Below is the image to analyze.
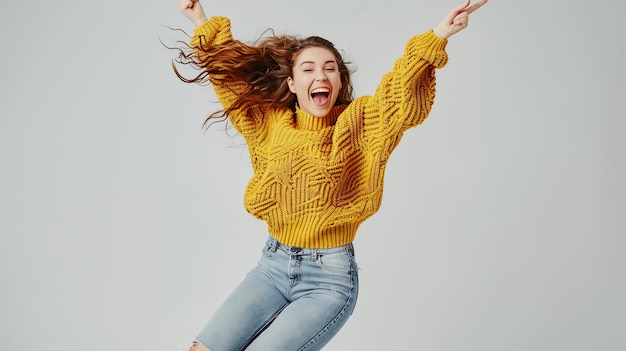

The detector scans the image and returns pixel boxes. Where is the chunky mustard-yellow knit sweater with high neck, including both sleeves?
[191,17,448,248]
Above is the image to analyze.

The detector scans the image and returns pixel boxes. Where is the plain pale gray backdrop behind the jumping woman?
[0,0,626,351]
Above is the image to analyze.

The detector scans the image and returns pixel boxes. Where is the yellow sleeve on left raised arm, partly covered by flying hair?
[191,16,256,139]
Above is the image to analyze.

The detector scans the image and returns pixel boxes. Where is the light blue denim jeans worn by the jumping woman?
[196,237,359,351]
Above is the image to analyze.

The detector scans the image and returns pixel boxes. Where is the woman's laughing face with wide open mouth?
[287,47,342,117]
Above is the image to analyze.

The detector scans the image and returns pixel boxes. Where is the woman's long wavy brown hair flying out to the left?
[172,30,353,126]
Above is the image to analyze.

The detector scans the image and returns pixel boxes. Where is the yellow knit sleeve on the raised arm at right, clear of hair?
[359,30,448,159]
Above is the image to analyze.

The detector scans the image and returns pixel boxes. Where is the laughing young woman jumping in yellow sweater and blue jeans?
[176,0,487,351]
